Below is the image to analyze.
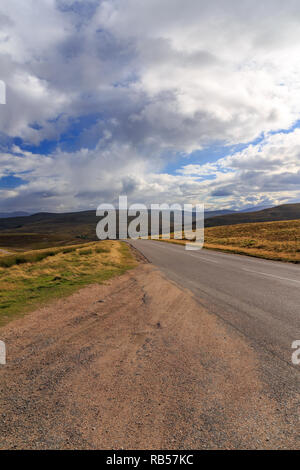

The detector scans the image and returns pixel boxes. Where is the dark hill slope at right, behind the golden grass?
[205,203,300,227]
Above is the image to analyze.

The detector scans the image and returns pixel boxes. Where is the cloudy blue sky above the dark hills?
[0,0,300,212]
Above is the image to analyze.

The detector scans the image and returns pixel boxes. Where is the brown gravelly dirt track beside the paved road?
[0,264,299,449]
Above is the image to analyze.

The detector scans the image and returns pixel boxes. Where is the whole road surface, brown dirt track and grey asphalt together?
[0,241,300,450]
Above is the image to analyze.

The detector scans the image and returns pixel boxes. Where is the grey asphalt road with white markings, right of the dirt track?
[130,240,300,392]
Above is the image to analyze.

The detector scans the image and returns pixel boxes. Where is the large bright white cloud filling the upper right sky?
[96,0,300,146]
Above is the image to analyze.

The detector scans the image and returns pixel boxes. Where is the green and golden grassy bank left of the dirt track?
[0,241,136,326]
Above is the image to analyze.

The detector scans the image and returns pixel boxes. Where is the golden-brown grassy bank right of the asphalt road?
[157,220,300,263]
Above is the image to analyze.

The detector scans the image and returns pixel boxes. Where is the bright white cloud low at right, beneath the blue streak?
[178,129,300,207]
